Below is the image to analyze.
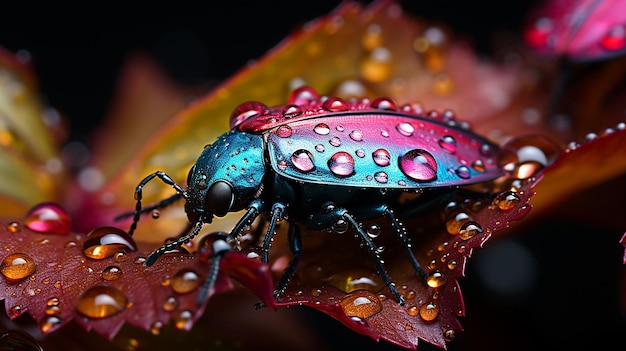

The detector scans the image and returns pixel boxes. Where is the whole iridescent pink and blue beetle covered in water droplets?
[123,87,503,304]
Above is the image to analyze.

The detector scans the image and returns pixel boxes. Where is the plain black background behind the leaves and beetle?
[0,0,626,350]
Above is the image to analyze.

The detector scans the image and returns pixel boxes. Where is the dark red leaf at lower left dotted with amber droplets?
[0,208,273,339]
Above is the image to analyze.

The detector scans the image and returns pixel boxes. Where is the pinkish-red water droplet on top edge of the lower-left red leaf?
[24,202,71,234]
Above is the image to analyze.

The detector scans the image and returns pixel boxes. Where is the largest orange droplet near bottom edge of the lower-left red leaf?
[76,285,128,318]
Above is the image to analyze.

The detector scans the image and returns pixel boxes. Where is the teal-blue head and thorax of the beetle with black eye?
[185,131,265,223]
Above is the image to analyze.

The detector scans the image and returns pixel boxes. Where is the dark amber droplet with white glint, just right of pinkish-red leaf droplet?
[83,227,137,260]
